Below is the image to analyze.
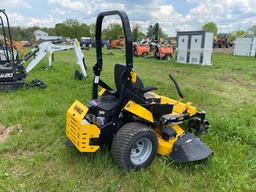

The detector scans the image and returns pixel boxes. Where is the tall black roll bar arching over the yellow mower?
[92,10,133,99]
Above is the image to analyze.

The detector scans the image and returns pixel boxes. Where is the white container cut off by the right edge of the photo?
[233,37,256,57]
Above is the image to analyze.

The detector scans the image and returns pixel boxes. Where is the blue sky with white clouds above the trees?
[0,0,256,36]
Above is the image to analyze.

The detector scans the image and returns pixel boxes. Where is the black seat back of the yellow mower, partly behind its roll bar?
[114,64,144,95]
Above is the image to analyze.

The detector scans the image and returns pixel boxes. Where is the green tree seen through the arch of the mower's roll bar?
[102,23,124,39]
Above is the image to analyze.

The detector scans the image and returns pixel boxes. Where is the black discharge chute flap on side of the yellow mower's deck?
[169,133,213,163]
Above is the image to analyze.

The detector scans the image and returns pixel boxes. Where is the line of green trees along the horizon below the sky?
[0,19,256,41]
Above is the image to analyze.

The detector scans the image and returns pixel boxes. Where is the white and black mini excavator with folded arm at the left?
[0,10,87,91]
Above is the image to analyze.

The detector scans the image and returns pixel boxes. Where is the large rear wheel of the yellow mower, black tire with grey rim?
[111,122,158,170]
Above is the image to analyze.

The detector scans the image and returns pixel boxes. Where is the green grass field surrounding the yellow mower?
[0,49,256,192]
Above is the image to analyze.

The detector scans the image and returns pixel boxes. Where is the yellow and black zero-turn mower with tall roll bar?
[66,11,212,170]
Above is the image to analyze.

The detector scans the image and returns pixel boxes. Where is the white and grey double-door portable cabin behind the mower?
[176,31,213,65]
